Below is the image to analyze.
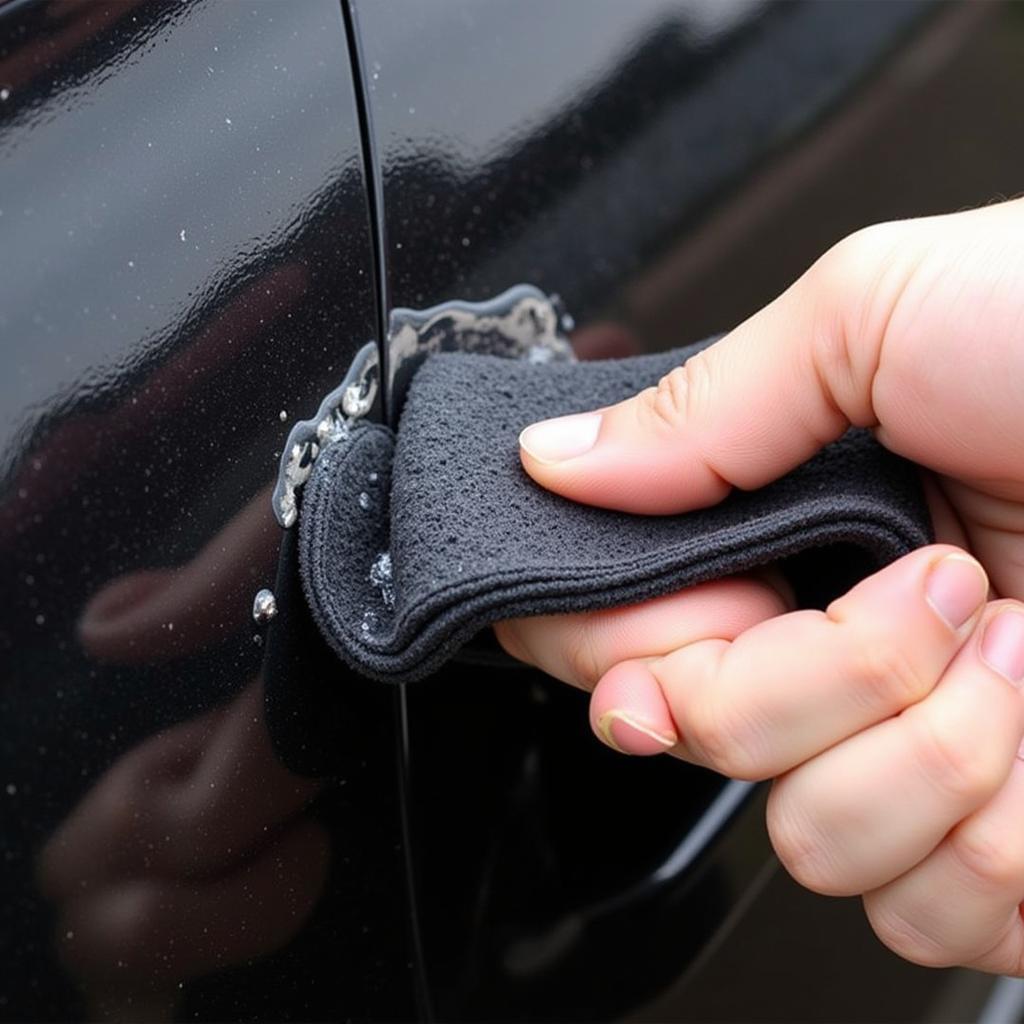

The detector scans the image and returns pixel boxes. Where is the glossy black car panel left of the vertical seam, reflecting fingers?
[0,0,415,1020]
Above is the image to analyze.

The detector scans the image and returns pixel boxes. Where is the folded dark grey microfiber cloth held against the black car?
[299,345,930,683]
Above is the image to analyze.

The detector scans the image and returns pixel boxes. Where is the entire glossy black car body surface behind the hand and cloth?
[0,0,1024,1021]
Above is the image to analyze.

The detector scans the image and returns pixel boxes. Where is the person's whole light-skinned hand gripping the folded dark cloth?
[496,201,1024,976]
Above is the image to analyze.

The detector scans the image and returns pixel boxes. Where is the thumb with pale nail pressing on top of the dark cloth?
[519,222,919,514]
